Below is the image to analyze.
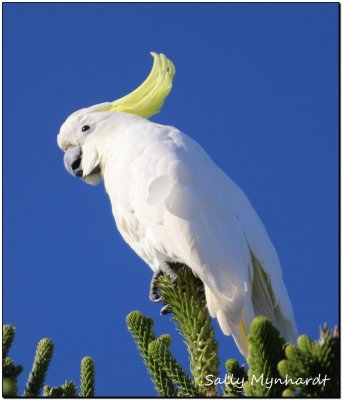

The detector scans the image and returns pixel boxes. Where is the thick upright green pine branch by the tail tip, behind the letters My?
[244,317,285,397]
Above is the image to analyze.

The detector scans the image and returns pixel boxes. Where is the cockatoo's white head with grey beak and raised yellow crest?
[57,53,175,184]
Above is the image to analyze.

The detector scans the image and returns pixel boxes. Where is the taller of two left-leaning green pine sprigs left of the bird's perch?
[126,311,177,397]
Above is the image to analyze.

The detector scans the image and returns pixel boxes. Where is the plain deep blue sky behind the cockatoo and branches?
[3,3,338,396]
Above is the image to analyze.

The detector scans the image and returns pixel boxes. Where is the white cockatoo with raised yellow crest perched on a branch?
[57,53,297,357]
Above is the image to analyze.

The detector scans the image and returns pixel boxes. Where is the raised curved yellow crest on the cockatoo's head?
[97,52,175,118]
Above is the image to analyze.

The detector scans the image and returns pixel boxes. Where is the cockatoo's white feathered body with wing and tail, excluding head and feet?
[99,116,297,356]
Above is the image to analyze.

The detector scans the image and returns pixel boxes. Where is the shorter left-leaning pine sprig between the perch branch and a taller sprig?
[148,335,203,397]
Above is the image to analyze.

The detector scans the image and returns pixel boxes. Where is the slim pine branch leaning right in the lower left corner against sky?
[23,339,53,397]
